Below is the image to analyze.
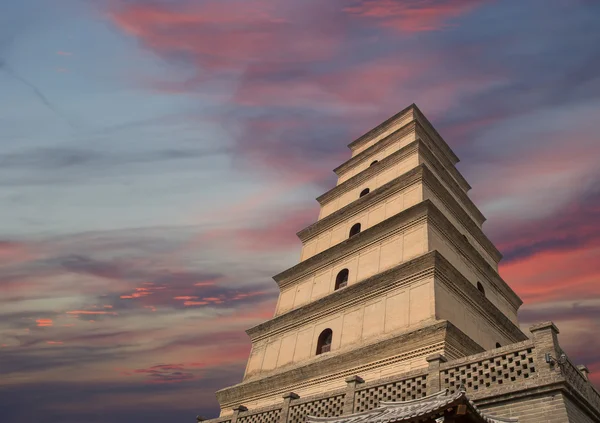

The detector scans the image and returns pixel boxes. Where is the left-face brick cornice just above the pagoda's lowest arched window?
[246,251,439,342]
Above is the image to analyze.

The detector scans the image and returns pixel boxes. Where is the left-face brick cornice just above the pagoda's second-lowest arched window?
[273,200,435,288]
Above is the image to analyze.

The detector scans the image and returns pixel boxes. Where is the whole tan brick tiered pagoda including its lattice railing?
[198,104,600,423]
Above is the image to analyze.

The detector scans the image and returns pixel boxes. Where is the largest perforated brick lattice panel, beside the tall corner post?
[440,347,536,391]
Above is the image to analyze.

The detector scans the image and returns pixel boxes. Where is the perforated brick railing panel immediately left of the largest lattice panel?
[354,375,427,413]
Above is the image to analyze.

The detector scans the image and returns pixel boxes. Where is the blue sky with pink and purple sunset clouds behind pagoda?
[0,0,600,423]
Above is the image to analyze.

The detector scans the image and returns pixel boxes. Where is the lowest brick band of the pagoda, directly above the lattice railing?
[216,320,484,416]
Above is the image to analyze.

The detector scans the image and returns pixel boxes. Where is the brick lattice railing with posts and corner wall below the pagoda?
[197,322,600,423]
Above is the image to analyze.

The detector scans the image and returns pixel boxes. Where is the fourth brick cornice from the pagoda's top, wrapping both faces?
[297,161,502,262]
